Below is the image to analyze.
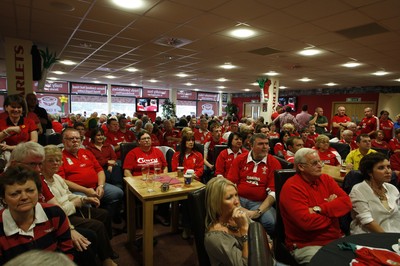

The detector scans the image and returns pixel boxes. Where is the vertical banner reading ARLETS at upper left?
[5,37,33,95]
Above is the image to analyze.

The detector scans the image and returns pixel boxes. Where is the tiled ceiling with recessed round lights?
[0,0,400,92]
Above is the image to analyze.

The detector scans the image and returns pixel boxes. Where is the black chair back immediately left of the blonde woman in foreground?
[188,187,211,266]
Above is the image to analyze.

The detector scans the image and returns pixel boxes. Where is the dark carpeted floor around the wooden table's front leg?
[111,221,199,266]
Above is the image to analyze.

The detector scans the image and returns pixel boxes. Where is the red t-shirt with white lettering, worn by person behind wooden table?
[123,147,168,176]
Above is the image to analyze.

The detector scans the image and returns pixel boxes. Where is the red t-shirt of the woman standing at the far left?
[0,117,38,146]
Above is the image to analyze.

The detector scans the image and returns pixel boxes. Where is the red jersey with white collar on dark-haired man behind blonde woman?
[227,152,282,201]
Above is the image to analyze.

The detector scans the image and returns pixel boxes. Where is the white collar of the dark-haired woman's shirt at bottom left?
[2,203,49,237]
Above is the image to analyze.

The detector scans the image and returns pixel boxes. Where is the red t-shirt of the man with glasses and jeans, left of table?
[58,149,103,189]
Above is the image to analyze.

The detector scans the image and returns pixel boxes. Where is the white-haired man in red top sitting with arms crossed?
[279,148,351,264]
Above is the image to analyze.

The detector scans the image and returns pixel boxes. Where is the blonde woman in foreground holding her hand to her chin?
[204,177,250,266]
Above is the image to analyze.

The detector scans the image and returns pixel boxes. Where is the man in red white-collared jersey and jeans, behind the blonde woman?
[227,133,282,235]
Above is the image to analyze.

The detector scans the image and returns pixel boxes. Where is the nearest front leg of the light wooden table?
[143,201,154,266]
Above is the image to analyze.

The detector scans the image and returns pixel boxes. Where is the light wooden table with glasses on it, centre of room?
[124,172,204,266]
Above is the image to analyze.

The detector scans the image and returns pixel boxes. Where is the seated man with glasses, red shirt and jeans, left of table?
[58,128,124,220]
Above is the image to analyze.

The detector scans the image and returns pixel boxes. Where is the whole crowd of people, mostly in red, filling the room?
[0,94,400,265]
